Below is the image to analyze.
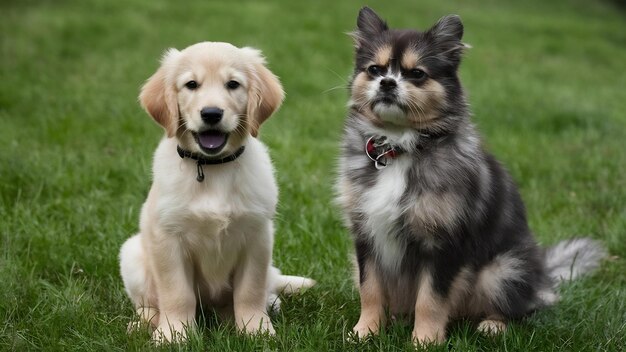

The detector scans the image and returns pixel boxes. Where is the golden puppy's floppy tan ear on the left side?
[139,49,180,137]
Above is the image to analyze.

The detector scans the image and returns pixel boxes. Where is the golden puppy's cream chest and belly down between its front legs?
[144,141,278,287]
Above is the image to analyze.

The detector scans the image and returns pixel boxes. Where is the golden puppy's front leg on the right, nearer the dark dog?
[233,223,274,335]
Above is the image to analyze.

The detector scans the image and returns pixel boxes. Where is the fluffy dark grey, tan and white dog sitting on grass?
[337,8,605,343]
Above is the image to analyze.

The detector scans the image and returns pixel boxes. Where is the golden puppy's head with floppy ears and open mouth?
[139,42,284,156]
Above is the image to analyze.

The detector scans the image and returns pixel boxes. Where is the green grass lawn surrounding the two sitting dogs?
[0,0,626,351]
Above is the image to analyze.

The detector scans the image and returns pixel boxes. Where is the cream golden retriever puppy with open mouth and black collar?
[120,42,314,341]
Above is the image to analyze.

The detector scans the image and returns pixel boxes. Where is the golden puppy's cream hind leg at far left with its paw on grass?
[120,235,159,331]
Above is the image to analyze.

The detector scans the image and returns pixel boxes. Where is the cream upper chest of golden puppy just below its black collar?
[154,139,278,228]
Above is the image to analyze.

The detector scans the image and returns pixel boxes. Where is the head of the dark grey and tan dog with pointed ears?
[350,7,466,129]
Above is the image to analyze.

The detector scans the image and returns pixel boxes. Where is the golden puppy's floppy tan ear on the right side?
[242,48,285,137]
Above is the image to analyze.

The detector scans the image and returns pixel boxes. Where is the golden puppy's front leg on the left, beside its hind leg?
[150,237,196,342]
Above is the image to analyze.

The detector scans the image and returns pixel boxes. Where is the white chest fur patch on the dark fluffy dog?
[360,157,411,272]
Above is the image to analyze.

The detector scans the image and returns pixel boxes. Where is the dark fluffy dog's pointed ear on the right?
[427,15,470,63]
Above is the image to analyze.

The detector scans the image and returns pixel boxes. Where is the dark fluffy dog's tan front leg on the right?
[412,272,450,344]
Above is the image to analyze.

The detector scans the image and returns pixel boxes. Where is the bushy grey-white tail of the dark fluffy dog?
[545,238,607,287]
